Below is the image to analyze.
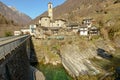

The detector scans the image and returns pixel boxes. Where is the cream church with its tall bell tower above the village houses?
[39,2,66,28]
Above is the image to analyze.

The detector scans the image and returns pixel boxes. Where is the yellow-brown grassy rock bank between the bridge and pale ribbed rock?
[32,38,61,65]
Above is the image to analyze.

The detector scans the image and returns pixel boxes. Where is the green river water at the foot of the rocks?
[36,64,73,80]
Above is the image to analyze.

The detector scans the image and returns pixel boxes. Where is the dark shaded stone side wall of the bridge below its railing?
[0,43,30,80]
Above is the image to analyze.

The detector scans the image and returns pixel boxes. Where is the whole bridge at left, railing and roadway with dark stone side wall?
[0,35,36,80]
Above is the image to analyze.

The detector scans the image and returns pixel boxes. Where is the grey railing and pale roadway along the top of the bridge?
[0,35,30,60]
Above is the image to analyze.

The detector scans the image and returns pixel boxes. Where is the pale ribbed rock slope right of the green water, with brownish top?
[60,39,115,77]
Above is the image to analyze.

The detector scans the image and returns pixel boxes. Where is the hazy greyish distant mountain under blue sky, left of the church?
[0,2,31,25]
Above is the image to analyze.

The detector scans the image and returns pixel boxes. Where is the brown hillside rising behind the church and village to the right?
[32,0,120,39]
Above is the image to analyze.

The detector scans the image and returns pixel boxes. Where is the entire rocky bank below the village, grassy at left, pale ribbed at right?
[33,38,119,78]
